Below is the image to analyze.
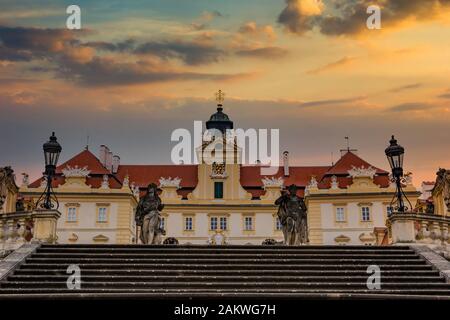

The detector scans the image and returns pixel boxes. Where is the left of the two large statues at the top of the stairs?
[135,183,165,244]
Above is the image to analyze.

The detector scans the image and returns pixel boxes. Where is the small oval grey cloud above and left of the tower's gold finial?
[134,41,225,65]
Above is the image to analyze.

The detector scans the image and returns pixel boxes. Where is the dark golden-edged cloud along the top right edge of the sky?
[278,0,450,36]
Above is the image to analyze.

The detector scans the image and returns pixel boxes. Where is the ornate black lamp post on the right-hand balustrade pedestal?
[385,136,409,212]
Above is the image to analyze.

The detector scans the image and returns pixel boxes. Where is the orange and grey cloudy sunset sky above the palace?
[0,0,450,186]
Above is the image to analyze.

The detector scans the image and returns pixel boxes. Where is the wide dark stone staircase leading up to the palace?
[0,245,450,299]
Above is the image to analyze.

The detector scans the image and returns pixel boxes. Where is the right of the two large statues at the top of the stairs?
[275,185,309,245]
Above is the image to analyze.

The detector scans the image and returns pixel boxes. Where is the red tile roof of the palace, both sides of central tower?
[25,150,389,198]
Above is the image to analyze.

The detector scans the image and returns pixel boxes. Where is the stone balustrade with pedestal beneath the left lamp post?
[0,210,61,253]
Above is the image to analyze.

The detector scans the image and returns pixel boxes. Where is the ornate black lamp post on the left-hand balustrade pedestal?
[36,132,62,210]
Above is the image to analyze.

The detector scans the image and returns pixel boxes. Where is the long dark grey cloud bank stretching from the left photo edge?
[0,24,249,86]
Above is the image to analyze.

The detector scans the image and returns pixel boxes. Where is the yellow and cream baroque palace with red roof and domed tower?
[19,104,419,245]
